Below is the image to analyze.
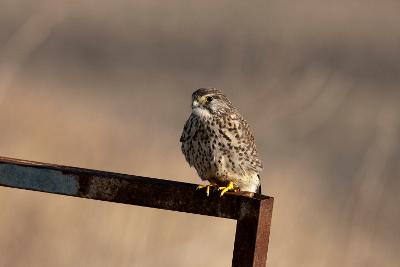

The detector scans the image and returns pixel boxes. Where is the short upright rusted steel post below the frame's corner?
[232,197,274,267]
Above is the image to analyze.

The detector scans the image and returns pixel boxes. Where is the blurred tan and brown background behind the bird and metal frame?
[0,0,400,267]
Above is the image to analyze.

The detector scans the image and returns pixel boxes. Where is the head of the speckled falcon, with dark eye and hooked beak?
[192,88,234,117]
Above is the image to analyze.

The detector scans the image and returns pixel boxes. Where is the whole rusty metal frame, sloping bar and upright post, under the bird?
[0,157,274,267]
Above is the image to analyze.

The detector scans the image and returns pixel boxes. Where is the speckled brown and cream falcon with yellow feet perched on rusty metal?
[180,88,263,196]
